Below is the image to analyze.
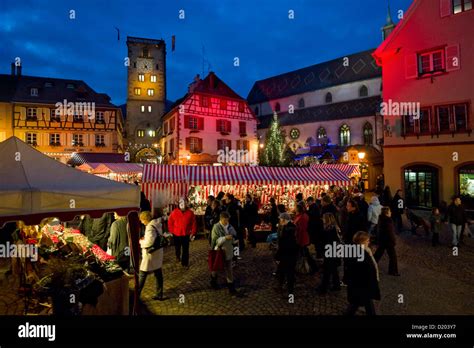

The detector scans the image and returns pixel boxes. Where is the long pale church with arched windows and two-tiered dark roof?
[247,50,383,188]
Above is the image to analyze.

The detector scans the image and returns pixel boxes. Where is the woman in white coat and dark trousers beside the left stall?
[138,211,164,301]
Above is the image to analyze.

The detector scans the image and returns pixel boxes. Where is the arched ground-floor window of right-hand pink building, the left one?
[404,166,439,208]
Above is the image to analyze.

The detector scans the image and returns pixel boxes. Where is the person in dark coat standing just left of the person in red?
[275,213,298,295]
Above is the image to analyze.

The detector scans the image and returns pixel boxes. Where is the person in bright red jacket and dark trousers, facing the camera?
[168,198,196,267]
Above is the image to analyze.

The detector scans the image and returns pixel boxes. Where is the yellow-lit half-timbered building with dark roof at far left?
[0,67,124,163]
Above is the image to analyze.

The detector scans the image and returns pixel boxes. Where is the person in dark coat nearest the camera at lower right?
[344,232,380,316]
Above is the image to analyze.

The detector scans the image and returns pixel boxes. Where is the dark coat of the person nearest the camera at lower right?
[344,251,380,306]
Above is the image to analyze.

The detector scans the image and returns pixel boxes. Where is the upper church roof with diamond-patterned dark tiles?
[247,49,382,104]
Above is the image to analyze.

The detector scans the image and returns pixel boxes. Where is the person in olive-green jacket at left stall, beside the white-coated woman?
[107,213,130,269]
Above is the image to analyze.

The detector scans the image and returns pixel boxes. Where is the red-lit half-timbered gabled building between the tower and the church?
[161,72,258,165]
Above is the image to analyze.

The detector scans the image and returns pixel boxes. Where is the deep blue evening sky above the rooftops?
[0,0,412,104]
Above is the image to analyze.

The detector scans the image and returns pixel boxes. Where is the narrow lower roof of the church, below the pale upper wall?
[258,96,382,129]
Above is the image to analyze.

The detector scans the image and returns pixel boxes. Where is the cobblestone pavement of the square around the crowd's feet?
[136,222,474,315]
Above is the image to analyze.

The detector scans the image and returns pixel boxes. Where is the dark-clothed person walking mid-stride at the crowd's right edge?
[374,207,400,276]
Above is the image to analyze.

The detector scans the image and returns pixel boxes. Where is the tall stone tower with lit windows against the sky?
[125,36,166,162]
